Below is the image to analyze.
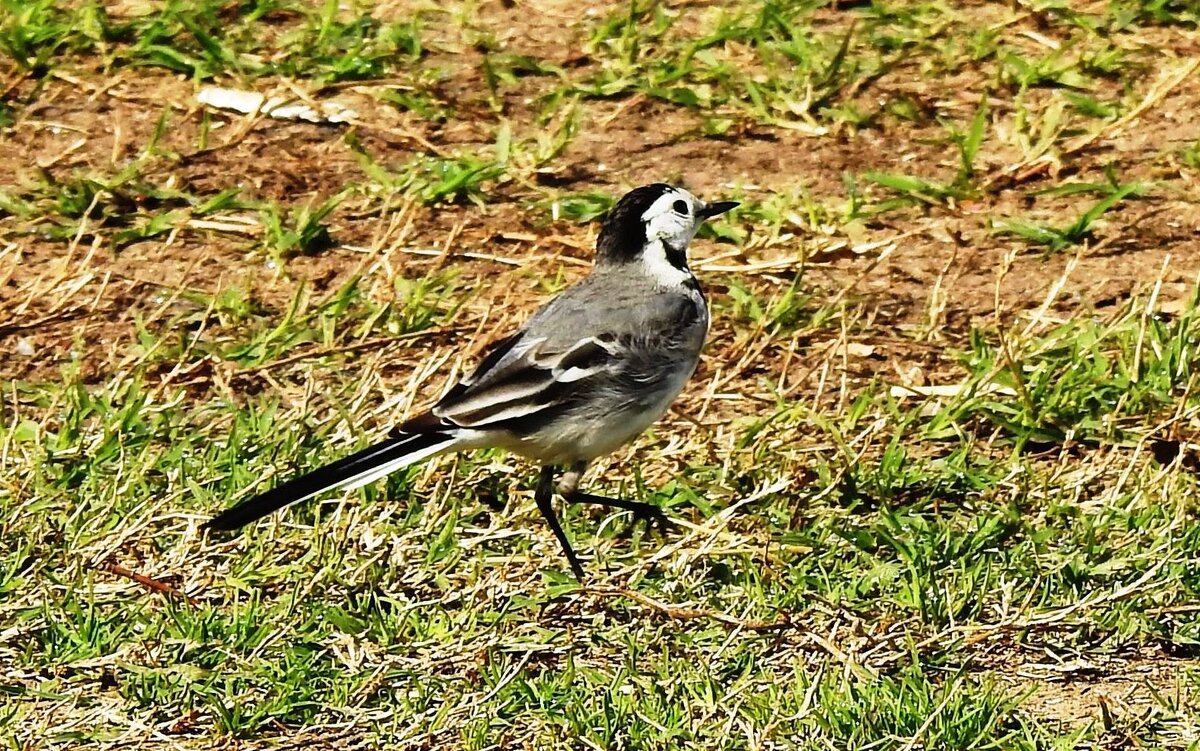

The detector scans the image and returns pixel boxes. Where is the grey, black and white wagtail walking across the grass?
[205,182,737,581]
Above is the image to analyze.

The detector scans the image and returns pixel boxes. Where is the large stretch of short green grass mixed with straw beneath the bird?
[9,279,1200,749]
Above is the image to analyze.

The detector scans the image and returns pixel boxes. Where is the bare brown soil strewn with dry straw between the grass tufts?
[0,2,1200,722]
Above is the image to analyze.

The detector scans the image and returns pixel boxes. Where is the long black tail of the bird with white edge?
[204,433,455,529]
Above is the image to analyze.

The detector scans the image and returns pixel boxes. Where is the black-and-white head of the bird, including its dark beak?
[596,182,738,271]
